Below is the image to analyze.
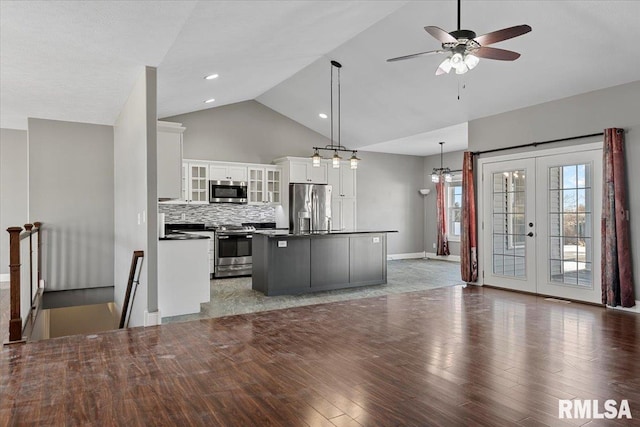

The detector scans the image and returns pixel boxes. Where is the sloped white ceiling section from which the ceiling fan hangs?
[257,0,640,154]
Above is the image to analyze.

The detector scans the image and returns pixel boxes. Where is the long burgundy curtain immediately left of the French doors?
[460,151,478,283]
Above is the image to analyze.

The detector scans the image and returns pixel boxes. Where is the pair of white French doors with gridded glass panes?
[481,144,602,303]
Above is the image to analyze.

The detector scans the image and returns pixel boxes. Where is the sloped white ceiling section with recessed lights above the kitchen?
[158,1,404,117]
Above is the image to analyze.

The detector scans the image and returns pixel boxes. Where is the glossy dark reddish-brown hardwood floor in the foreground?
[0,287,640,427]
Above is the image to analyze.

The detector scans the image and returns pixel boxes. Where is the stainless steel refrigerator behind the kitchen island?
[289,184,332,234]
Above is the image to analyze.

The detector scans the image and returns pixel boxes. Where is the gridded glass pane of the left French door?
[492,170,526,278]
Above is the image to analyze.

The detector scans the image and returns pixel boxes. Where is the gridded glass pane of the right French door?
[548,164,593,287]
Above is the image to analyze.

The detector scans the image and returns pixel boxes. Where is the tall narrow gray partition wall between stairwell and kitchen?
[111,67,158,326]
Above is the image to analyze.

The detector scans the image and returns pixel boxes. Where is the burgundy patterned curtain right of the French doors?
[601,128,635,307]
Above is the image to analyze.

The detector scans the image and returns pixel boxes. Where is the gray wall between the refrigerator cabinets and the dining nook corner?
[357,151,424,255]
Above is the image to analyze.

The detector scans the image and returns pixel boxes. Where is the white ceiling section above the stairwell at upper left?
[0,0,196,129]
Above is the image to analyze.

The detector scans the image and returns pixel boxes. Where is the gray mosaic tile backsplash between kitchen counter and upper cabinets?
[158,203,276,225]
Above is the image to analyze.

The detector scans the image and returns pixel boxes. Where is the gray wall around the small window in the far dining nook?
[422,151,464,256]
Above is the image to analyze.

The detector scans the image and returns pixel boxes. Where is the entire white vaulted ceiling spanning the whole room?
[0,0,640,155]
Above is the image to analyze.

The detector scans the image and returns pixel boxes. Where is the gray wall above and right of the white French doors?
[469,81,640,299]
